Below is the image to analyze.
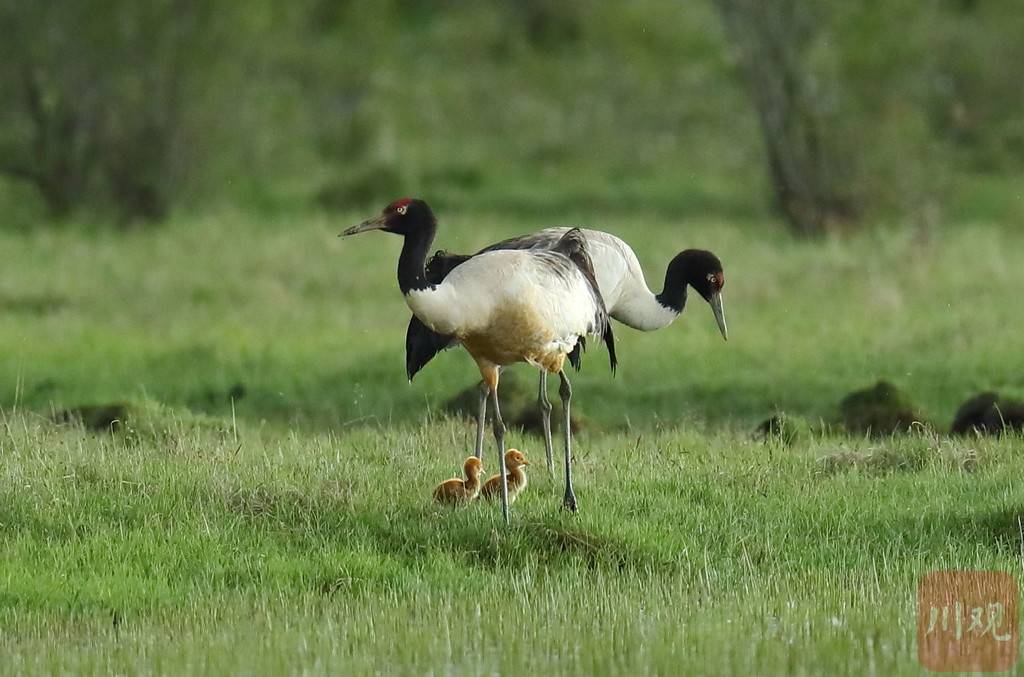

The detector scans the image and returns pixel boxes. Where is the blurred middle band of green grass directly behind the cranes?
[0,212,1024,430]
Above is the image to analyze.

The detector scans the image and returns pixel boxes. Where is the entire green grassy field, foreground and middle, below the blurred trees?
[0,212,1024,675]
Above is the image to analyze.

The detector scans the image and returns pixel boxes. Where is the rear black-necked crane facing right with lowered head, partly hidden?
[406,227,728,472]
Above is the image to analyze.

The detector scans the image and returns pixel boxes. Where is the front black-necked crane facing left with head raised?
[342,198,614,523]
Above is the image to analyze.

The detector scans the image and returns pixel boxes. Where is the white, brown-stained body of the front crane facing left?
[406,250,602,372]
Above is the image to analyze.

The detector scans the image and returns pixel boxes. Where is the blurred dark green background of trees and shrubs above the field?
[0,0,1024,235]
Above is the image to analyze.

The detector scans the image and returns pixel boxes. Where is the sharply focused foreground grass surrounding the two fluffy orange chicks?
[0,416,1024,674]
